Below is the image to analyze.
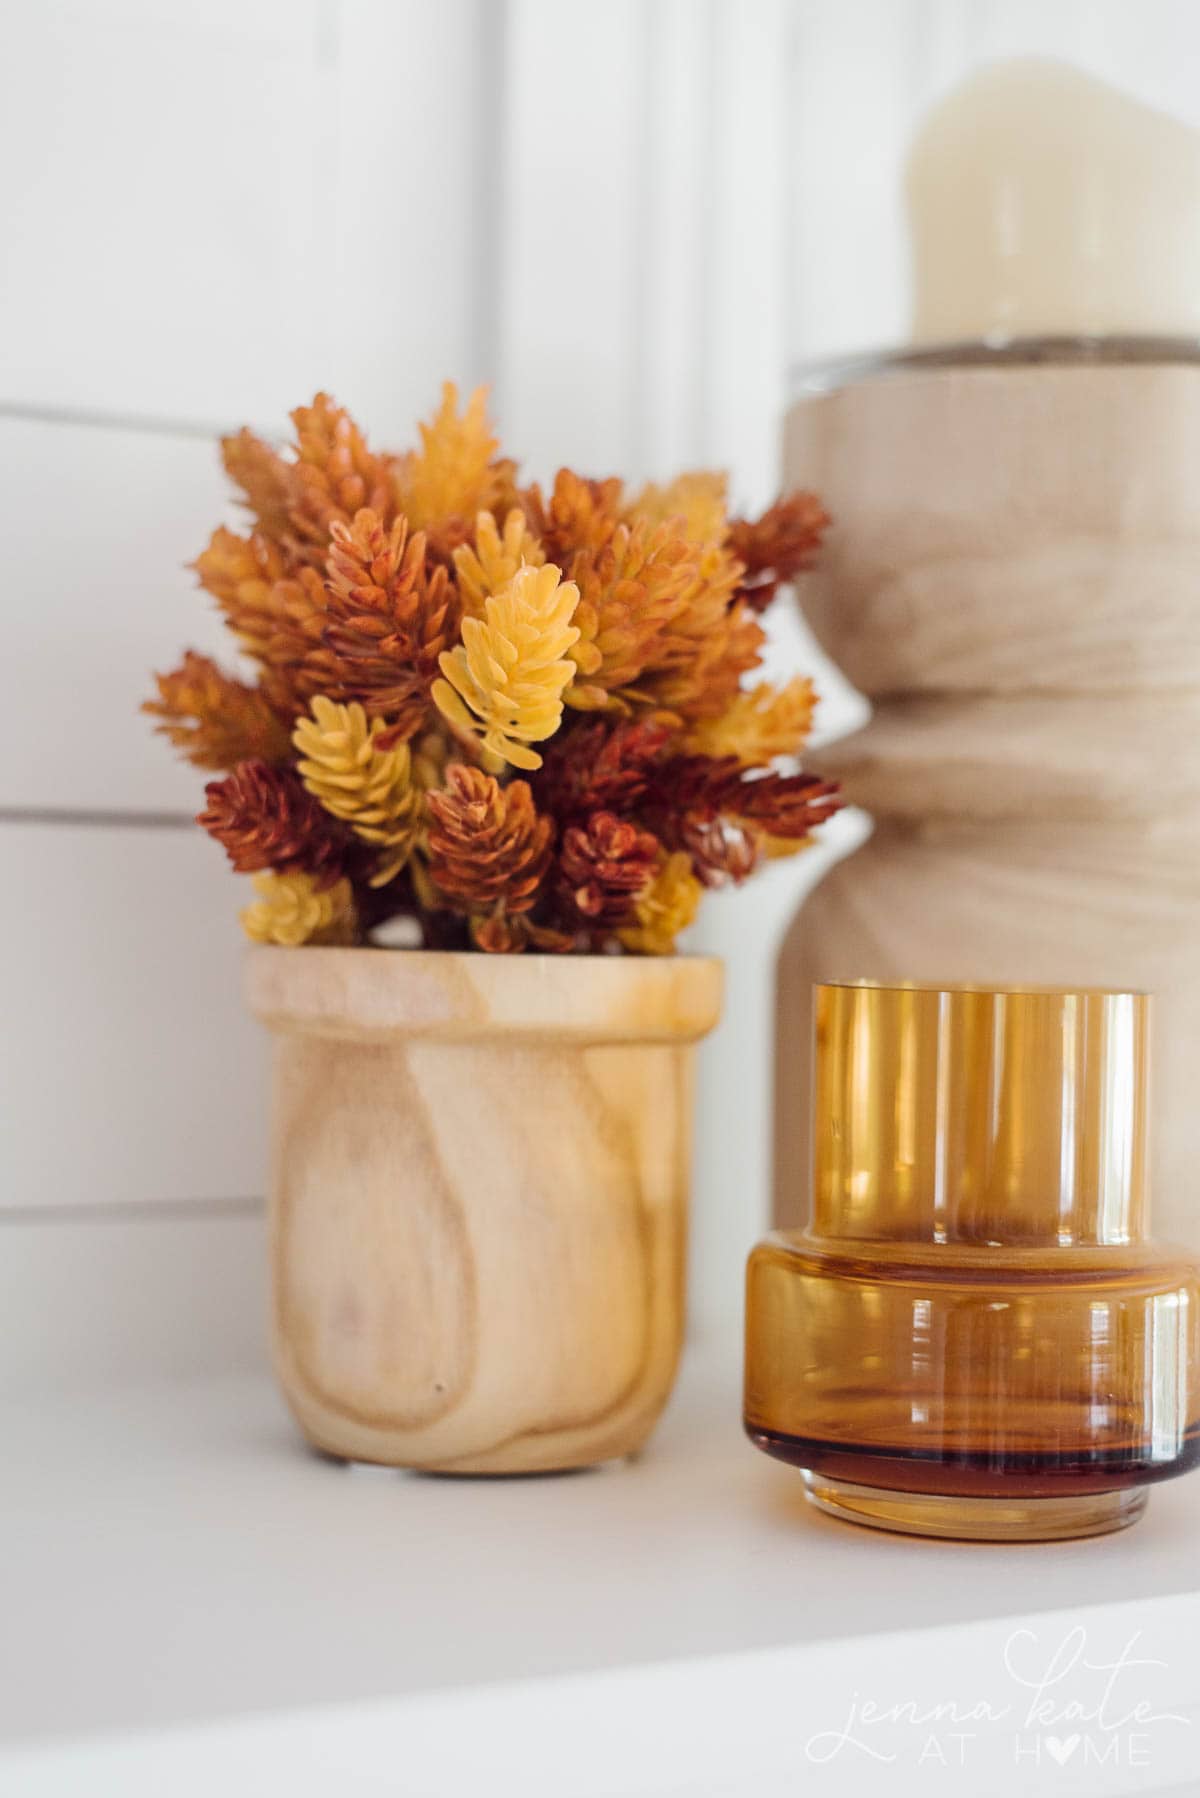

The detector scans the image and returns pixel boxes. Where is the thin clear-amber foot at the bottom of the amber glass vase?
[802,1467,1148,1543]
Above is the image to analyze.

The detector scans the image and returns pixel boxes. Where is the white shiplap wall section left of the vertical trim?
[0,0,502,1375]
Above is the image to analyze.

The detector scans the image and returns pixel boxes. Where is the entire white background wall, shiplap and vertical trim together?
[0,0,1196,1374]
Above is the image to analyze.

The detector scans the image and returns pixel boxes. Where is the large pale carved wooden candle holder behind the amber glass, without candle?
[777,354,1200,1246]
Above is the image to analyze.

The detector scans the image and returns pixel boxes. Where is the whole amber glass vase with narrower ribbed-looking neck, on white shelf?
[745,984,1200,1541]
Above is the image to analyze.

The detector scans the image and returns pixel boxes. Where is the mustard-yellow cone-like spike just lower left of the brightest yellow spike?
[291,694,421,886]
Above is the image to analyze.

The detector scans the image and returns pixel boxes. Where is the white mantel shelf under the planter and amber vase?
[0,1340,1200,1798]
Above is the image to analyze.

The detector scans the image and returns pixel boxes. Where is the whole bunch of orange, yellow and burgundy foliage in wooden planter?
[144,383,838,955]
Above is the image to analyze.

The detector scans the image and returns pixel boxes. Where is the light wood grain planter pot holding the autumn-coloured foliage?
[239,948,721,1473]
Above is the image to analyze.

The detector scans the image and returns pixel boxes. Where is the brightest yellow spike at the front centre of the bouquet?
[432,563,579,768]
